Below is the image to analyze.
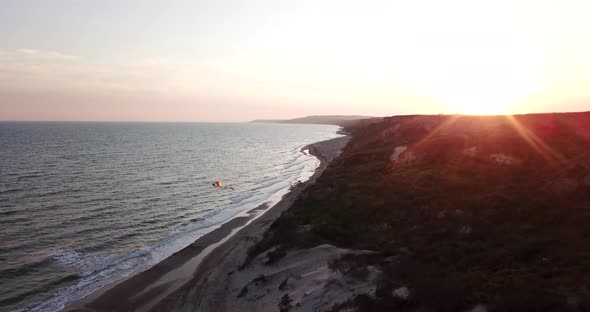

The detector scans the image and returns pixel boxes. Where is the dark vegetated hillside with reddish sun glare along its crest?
[243,113,590,311]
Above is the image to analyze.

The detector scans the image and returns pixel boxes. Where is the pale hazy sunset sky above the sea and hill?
[0,0,590,121]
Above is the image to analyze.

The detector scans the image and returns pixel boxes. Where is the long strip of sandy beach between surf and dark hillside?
[65,136,350,311]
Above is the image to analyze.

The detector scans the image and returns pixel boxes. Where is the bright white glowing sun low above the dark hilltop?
[404,33,539,115]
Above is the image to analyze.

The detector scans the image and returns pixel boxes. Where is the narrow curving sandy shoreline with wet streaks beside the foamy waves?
[64,136,350,311]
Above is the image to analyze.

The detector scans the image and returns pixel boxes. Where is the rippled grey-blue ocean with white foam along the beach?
[0,122,339,311]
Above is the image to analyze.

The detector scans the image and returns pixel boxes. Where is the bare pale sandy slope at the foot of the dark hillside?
[198,245,380,311]
